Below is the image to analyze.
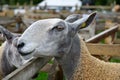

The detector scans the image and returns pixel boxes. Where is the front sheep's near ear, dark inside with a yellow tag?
[73,12,96,31]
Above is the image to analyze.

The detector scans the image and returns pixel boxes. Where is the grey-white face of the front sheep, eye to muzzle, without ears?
[18,19,72,57]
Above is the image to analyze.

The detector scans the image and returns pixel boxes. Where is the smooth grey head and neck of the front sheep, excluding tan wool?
[17,12,96,80]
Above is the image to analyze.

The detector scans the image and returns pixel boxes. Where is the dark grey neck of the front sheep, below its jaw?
[56,35,80,80]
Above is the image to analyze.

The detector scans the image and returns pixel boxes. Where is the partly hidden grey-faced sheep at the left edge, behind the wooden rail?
[0,26,27,80]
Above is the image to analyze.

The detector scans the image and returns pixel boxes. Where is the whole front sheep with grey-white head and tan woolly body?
[17,13,120,80]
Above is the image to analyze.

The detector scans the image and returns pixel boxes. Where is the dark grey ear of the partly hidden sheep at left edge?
[0,26,14,41]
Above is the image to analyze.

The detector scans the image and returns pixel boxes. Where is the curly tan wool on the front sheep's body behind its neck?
[72,40,120,80]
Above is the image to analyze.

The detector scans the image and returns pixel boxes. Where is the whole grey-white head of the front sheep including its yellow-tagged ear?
[18,13,96,58]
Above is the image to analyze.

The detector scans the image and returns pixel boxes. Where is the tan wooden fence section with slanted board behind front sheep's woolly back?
[86,25,120,56]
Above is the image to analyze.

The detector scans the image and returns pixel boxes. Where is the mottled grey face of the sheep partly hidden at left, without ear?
[4,35,26,67]
